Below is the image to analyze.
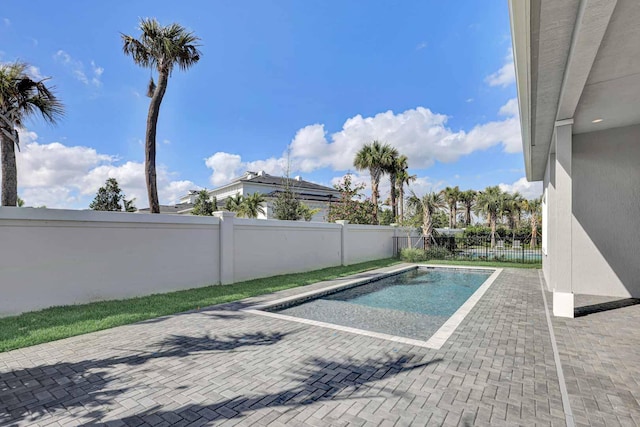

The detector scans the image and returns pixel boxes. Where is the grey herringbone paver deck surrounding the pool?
[0,269,640,426]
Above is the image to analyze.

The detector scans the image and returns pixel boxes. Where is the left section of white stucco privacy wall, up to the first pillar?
[0,207,220,315]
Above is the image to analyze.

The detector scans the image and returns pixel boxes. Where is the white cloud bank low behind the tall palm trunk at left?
[2,130,198,209]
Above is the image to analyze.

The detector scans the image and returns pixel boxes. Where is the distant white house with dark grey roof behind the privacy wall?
[178,171,340,221]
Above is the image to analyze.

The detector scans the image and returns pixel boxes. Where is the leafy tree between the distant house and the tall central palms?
[327,174,378,224]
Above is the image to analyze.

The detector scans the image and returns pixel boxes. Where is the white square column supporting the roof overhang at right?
[550,119,574,317]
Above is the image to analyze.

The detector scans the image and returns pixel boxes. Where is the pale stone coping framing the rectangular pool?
[242,264,503,350]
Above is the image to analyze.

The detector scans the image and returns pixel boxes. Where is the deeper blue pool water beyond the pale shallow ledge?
[323,269,491,316]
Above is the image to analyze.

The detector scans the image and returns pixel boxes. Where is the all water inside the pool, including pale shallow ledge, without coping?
[269,268,493,340]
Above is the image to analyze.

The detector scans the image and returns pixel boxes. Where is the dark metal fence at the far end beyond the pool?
[393,235,542,264]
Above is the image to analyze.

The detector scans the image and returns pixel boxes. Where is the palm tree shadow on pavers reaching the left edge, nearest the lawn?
[0,332,289,425]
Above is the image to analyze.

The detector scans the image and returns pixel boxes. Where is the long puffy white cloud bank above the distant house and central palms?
[205,100,522,185]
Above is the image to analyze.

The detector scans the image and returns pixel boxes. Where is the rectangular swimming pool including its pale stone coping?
[252,266,498,348]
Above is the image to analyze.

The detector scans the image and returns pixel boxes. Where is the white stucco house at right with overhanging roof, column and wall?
[509,0,640,317]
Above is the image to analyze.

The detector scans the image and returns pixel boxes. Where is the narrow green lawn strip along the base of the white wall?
[0,258,400,352]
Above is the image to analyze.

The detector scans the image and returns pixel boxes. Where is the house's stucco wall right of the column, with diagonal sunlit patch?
[572,126,640,297]
